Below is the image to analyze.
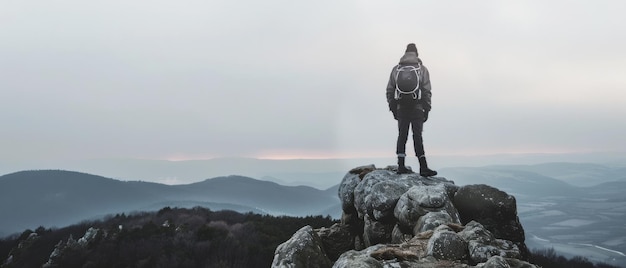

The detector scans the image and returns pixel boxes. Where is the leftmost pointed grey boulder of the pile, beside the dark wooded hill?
[272,225,332,268]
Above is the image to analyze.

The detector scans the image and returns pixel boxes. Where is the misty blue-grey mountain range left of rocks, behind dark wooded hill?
[0,170,340,236]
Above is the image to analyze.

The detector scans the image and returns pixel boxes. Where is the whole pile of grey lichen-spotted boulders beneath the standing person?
[272,165,535,268]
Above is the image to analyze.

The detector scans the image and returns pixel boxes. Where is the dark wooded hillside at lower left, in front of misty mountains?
[0,207,334,268]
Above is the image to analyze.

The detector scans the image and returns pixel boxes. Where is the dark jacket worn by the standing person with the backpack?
[387,52,432,117]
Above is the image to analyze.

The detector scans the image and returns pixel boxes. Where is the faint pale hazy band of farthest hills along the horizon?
[0,152,626,190]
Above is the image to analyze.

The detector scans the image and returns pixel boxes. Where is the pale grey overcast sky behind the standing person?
[0,0,626,161]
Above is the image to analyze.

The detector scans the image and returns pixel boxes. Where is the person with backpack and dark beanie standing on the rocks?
[387,43,437,177]
